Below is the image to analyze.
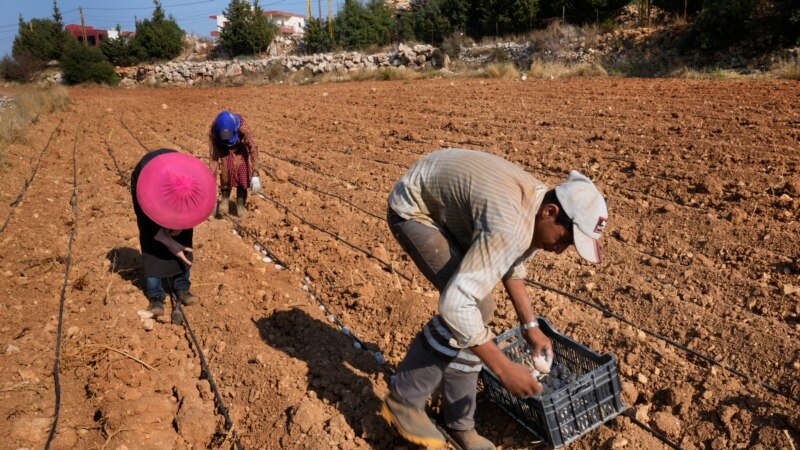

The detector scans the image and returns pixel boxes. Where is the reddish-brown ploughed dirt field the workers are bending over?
[0,79,800,450]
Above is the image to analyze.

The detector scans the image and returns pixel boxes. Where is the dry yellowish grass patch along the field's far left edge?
[0,86,69,160]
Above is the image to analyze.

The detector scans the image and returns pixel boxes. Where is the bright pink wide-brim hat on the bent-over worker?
[136,152,217,230]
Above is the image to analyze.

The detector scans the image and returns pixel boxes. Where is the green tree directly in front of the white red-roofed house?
[219,0,278,55]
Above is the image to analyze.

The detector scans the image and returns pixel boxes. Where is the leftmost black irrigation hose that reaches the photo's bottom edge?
[44,124,80,450]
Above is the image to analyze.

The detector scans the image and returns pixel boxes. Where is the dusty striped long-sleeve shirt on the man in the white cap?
[389,149,547,348]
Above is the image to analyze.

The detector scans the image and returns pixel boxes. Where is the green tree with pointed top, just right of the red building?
[136,0,185,60]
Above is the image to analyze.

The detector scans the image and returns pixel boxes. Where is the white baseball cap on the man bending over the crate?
[556,170,608,264]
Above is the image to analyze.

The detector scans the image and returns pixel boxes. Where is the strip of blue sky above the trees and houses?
[0,0,318,57]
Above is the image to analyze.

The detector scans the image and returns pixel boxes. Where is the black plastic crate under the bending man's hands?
[481,317,625,448]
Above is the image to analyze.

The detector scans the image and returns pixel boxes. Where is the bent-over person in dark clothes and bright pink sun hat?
[131,149,217,318]
